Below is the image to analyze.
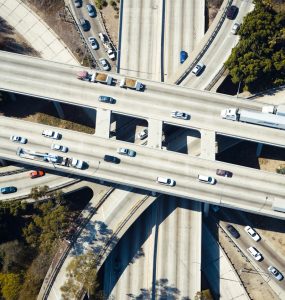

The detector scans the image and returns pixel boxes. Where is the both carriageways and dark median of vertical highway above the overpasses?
[119,0,205,81]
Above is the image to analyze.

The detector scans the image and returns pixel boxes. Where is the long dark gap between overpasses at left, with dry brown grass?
[0,92,96,134]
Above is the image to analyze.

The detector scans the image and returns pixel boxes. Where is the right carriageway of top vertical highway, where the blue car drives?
[163,0,205,80]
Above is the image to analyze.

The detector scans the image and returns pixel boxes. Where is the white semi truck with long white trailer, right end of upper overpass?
[221,108,285,130]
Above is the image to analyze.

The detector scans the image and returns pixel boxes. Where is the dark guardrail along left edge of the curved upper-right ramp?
[174,0,233,84]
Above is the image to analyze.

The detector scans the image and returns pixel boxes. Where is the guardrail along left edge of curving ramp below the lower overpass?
[37,187,115,300]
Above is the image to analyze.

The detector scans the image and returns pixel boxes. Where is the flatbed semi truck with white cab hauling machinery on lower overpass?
[16,147,84,169]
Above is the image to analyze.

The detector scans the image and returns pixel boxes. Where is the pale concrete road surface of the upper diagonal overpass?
[0,52,285,147]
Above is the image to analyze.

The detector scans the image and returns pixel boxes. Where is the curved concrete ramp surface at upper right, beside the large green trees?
[181,0,254,90]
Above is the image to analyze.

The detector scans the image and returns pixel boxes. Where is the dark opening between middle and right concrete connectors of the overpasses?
[162,123,201,155]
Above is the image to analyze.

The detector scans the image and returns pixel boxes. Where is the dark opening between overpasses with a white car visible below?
[110,113,148,145]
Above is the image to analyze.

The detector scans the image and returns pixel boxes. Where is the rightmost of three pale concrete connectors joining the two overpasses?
[200,129,217,160]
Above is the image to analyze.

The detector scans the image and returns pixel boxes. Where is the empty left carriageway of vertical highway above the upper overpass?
[119,0,162,81]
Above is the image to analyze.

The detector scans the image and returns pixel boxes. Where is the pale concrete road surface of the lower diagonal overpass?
[0,117,285,218]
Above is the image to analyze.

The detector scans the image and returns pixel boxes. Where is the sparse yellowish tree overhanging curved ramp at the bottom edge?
[61,251,99,300]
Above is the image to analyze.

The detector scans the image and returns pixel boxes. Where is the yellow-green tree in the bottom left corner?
[0,273,22,300]
